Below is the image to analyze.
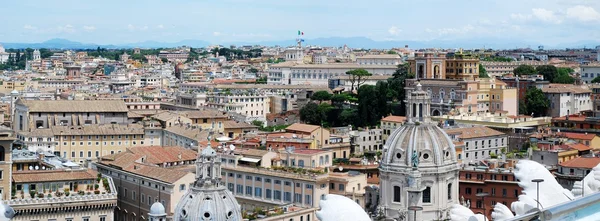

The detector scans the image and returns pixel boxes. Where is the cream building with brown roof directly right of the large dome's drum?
[445,127,508,162]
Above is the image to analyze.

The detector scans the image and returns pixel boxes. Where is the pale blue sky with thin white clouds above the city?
[0,0,600,45]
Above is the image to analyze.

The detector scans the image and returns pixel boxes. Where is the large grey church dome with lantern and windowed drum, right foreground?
[378,84,459,221]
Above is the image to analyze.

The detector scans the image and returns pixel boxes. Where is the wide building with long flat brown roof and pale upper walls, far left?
[13,99,128,131]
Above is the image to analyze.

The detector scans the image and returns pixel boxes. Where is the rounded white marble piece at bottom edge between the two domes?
[317,194,371,221]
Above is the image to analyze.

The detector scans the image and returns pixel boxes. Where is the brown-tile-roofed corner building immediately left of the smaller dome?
[94,146,198,220]
